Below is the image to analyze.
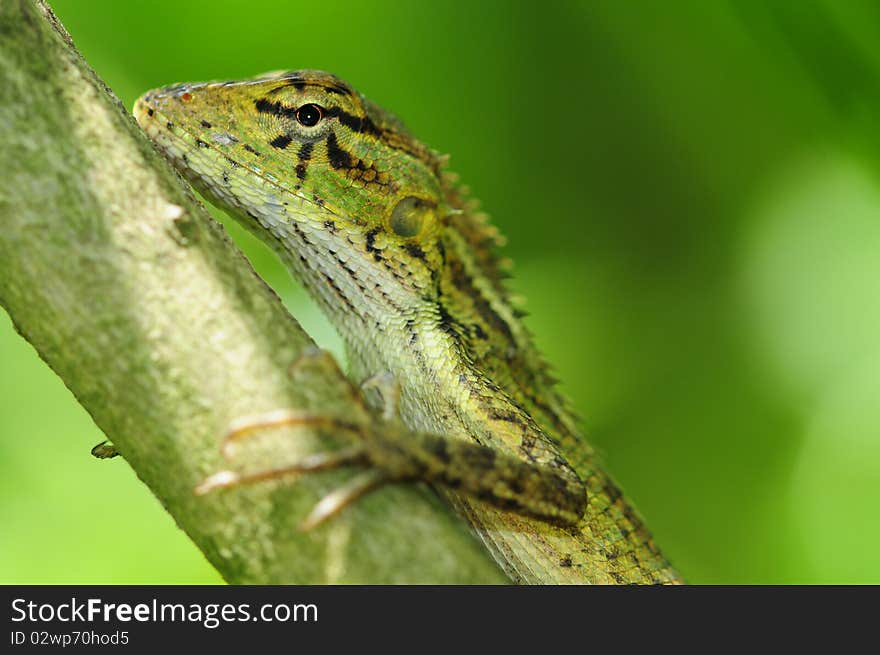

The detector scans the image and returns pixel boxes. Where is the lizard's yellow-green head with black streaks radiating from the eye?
[134,70,453,306]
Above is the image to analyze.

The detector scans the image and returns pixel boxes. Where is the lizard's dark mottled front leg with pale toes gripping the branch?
[195,410,586,530]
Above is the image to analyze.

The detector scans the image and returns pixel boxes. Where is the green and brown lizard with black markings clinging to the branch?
[134,70,680,583]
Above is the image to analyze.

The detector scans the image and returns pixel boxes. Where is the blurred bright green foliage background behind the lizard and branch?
[0,0,880,583]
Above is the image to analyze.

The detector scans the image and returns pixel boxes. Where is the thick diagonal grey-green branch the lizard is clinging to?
[0,0,504,583]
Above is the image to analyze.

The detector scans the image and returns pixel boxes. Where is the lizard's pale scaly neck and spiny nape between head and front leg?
[220,165,589,472]
